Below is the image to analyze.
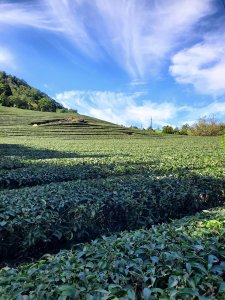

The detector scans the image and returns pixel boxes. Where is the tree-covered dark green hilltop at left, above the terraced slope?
[0,72,76,112]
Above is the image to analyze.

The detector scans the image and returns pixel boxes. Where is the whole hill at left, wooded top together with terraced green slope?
[0,72,156,138]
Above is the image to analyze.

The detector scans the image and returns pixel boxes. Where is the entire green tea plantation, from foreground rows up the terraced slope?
[0,106,225,300]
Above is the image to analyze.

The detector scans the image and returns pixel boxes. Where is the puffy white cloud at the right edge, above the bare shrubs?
[170,33,225,96]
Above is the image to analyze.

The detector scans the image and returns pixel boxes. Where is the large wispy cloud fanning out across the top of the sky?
[0,0,214,78]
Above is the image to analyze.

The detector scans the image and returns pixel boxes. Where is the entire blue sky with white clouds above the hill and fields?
[0,0,225,128]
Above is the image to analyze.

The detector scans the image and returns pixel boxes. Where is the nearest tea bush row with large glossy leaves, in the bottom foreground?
[0,208,225,300]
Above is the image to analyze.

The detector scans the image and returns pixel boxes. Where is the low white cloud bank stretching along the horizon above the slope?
[55,91,225,128]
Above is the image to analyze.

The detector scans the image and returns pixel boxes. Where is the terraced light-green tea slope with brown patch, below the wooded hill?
[0,105,151,139]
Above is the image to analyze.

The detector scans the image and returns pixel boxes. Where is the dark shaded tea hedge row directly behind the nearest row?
[0,175,225,257]
